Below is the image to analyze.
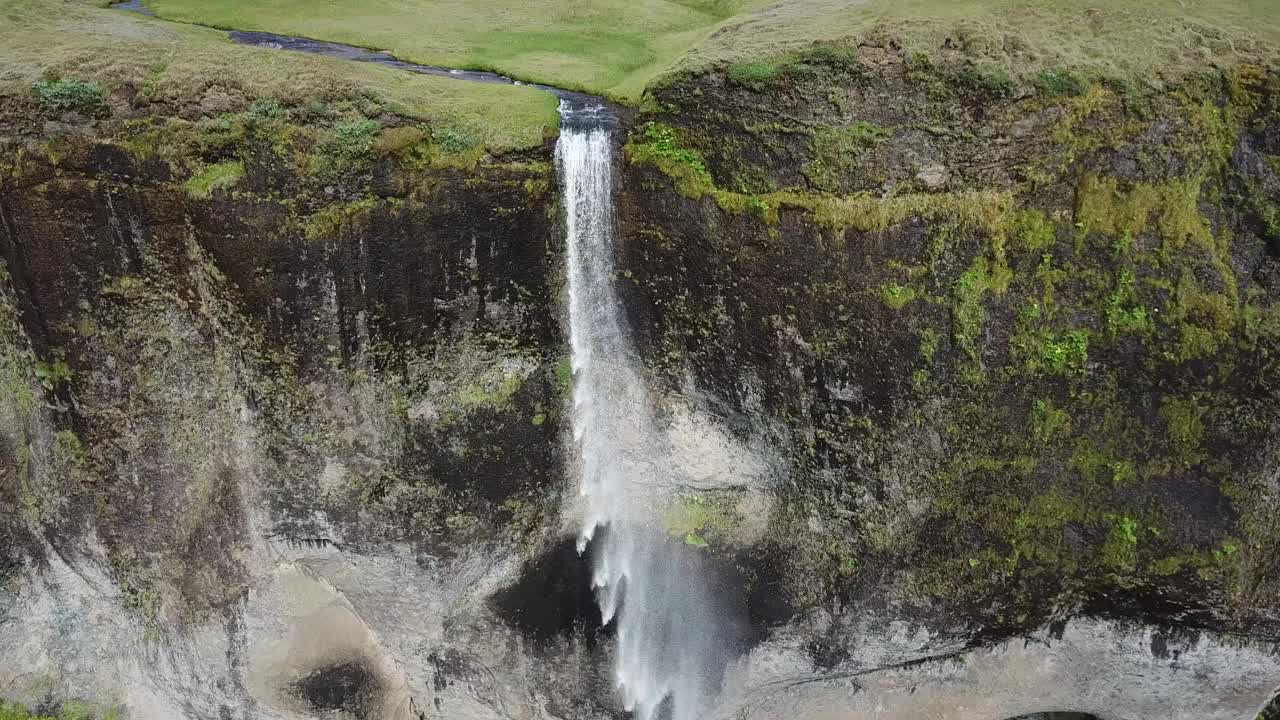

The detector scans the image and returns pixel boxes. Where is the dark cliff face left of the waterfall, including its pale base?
[0,96,614,717]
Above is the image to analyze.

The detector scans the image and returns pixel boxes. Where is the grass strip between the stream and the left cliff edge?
[0,0,558,151]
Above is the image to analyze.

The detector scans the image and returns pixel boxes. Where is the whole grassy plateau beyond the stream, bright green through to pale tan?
[145,0,1280,101]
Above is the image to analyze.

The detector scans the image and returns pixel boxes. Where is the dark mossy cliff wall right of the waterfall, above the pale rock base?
[621,47,1280,645]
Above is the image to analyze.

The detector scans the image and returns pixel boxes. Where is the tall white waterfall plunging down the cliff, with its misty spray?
[556,100,740,720]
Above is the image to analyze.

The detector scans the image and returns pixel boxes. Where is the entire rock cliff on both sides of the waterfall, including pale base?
[0,47,1280,719]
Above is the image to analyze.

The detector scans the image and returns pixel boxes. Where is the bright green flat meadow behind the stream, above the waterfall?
[147,0,763,100]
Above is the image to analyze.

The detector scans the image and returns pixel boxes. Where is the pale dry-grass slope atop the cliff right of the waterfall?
[681,0,1280,81]
